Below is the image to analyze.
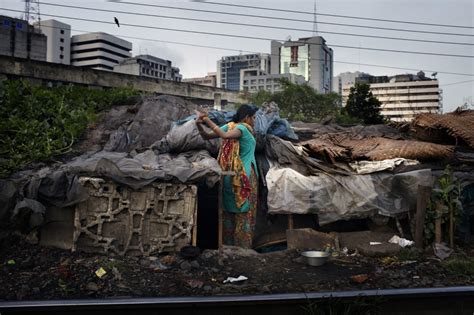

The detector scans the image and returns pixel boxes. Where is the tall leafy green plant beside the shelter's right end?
[424,165,462,247]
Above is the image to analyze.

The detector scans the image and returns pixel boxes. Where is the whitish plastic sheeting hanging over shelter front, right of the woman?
[266,165,432,225]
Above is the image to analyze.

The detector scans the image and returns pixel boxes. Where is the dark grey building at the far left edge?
[0,15,46,61]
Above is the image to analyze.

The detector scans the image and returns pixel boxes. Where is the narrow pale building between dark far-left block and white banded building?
[34,20,71,65]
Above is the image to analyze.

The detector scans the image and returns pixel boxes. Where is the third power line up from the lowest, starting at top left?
[41,2,474,46]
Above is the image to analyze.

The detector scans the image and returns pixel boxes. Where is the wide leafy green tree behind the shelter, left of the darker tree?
[251,79,339,122]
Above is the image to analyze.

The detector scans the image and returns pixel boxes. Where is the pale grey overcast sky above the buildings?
[0,0,474,112]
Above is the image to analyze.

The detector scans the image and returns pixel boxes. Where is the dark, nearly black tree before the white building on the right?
[345,83,384,125]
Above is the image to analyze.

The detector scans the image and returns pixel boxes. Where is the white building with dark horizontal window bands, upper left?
[71,32,132,70]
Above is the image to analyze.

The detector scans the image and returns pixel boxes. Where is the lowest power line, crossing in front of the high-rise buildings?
[33,21,474,78]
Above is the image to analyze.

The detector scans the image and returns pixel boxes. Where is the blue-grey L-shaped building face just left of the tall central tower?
[216,54,270,91]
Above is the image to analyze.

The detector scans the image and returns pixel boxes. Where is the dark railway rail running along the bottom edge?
[0,286,474,315]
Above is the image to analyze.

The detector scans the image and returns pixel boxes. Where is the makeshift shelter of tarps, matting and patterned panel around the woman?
[0,96,474,255]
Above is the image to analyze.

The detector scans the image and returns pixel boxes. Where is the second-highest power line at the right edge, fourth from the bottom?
[109,1,474,37]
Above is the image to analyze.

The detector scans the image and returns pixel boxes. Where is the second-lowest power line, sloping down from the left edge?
[4,9,474,58]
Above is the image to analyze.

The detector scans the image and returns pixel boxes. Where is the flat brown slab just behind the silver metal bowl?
[286,228,336,250]
